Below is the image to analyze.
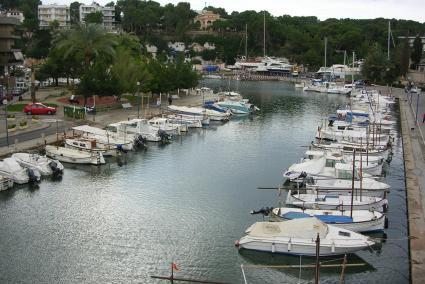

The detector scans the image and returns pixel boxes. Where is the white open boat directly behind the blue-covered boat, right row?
[286,190,388,212]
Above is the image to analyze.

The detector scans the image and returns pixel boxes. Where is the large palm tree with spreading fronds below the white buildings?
[55,24,118,71]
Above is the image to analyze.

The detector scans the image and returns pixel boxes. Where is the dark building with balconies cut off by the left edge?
[0,15,24,75]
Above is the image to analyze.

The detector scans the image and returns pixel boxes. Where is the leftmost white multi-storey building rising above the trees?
[38,4,71,28]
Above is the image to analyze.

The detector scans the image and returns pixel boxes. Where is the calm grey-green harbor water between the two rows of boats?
[0,80,409,283]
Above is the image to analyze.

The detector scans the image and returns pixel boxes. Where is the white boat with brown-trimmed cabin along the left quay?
[65,137,121,157]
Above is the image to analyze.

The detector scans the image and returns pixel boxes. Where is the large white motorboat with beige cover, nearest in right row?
[236,218,375,256]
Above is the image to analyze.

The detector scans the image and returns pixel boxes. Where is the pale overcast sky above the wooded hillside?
[42,0,425,23]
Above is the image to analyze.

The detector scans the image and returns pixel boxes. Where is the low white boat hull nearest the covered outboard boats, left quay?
[46,145,105,165]
